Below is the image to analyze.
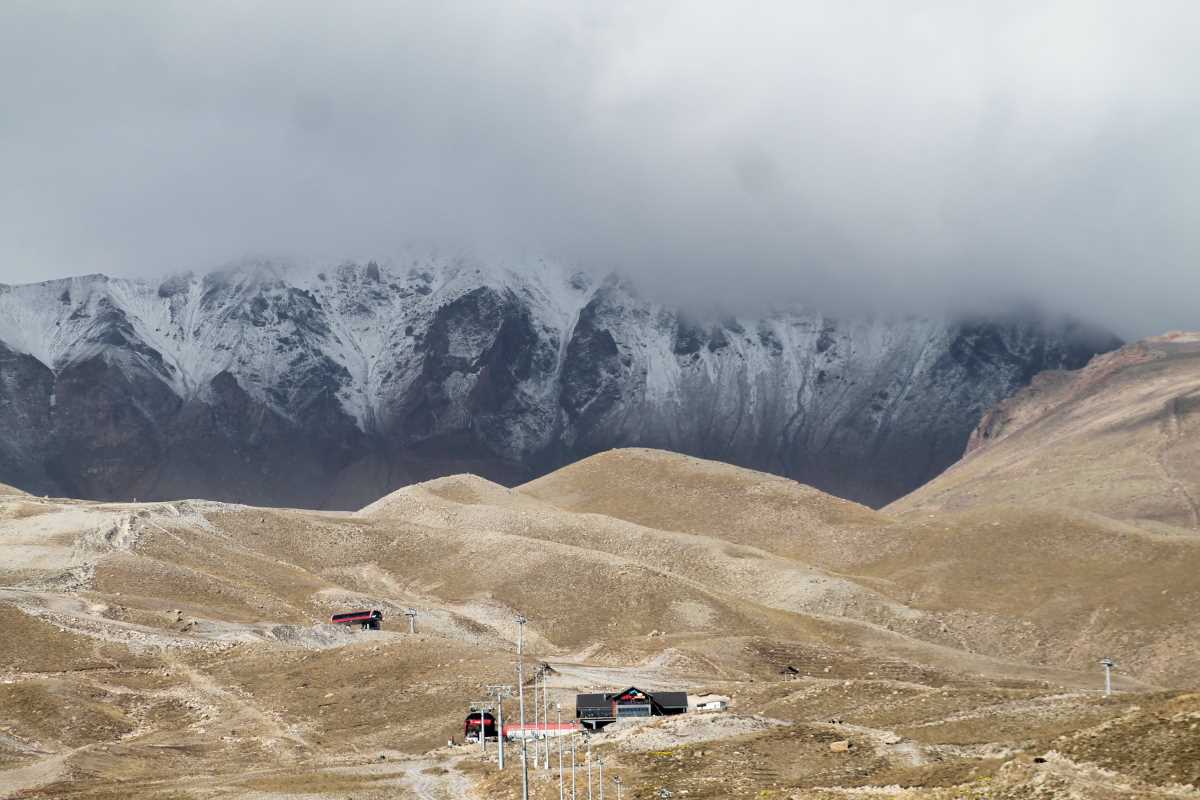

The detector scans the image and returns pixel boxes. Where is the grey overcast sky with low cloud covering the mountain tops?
[0,0,1200,337]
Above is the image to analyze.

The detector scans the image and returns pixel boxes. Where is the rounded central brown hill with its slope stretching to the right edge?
[518,450,1200,685]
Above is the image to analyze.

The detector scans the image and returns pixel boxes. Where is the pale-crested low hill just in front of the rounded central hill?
[355,474,893,649]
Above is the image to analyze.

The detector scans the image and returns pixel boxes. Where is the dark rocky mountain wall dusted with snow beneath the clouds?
[0,258,1118,507]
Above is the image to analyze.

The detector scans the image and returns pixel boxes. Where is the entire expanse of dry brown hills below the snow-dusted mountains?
[0,336,1200,800]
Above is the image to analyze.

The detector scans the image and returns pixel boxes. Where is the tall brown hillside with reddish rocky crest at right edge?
[884,333,1200,534]
